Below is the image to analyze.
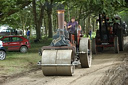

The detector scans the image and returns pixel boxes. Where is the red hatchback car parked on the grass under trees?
[1,36,30,53]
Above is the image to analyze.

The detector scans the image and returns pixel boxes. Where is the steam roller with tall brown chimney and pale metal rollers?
[40,9,92,76]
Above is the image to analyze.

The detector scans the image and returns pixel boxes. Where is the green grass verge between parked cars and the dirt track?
[0,38,52,76]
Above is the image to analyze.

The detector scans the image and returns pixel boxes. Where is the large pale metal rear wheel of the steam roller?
[79,38,92,68]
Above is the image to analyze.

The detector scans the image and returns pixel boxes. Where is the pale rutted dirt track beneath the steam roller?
[3,37,128,85]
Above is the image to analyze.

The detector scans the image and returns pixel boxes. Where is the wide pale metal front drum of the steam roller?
[42,50,75,76]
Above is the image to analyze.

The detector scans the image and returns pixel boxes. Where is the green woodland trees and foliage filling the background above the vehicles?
[0,0,128,39]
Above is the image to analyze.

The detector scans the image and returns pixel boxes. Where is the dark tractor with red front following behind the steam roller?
[92,14,124,53]
